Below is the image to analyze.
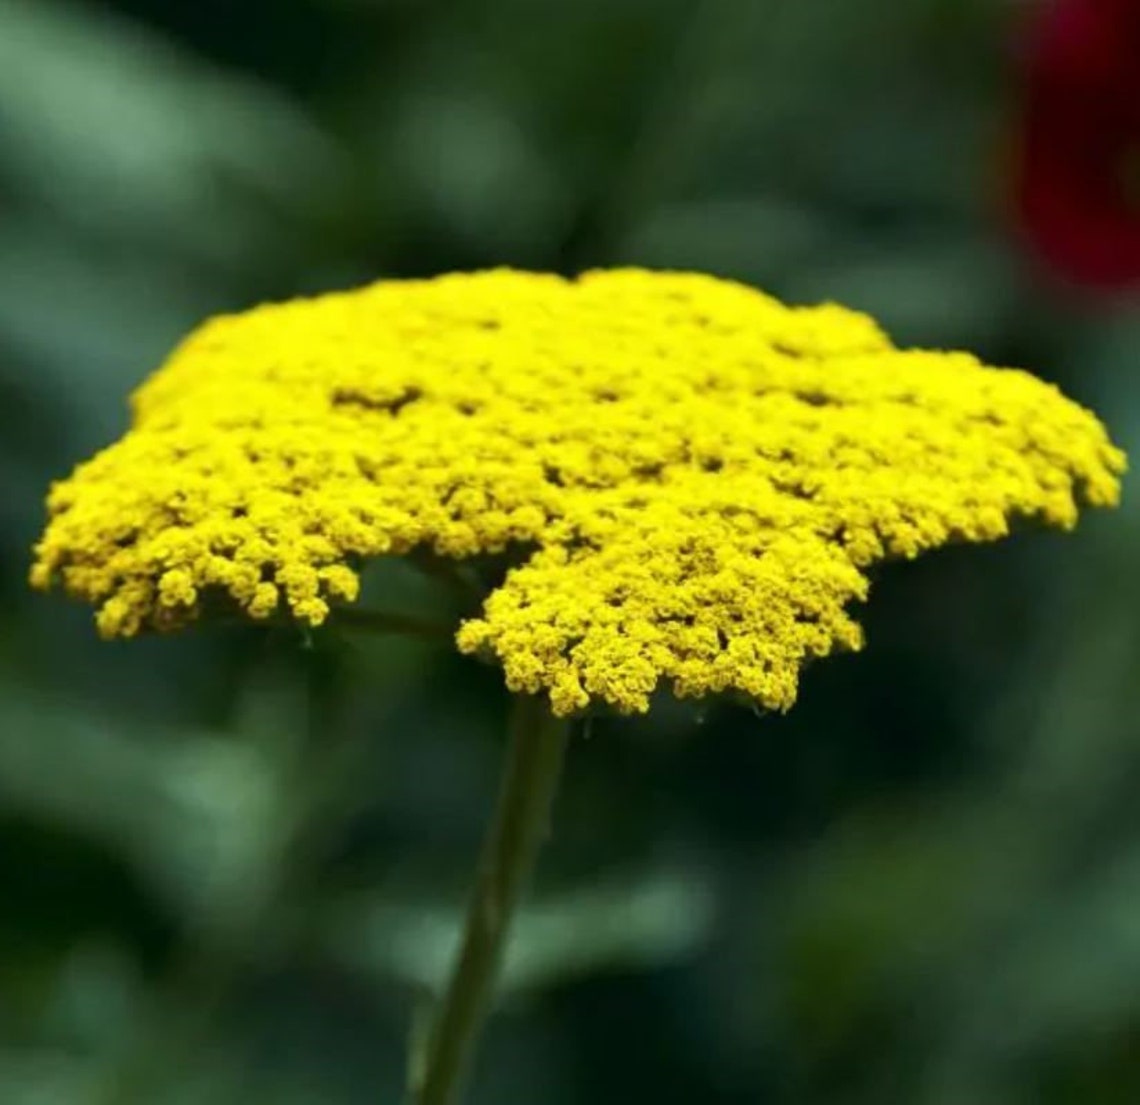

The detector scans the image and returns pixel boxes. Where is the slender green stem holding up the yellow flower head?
[413,697,570,1105]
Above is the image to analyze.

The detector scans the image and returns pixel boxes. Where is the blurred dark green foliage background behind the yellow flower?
[0,0,1140,1105]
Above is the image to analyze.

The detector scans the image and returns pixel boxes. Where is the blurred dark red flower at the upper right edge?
[1017,0,1140,287]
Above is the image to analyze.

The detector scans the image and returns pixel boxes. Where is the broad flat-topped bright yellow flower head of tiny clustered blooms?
[32,269,1124,714]
